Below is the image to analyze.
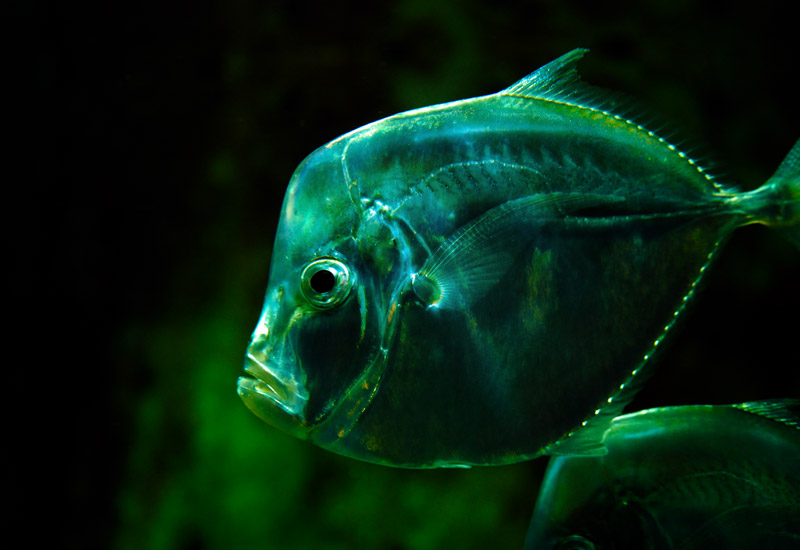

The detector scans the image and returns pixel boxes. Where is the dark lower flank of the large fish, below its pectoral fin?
[326,219,732,463]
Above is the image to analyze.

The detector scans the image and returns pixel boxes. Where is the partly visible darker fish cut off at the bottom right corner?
[525,399,800,550]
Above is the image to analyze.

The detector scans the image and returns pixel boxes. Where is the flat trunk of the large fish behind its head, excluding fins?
[314,75,735,465]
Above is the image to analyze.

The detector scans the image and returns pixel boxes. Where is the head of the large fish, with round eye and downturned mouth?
[238,142,400,446]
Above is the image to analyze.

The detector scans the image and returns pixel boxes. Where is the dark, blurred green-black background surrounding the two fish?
[36,0,800,550]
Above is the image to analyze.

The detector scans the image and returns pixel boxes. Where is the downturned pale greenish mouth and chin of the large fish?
[236,350,308,439]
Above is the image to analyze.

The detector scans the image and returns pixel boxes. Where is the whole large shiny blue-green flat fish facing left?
[238,50,800,467]
